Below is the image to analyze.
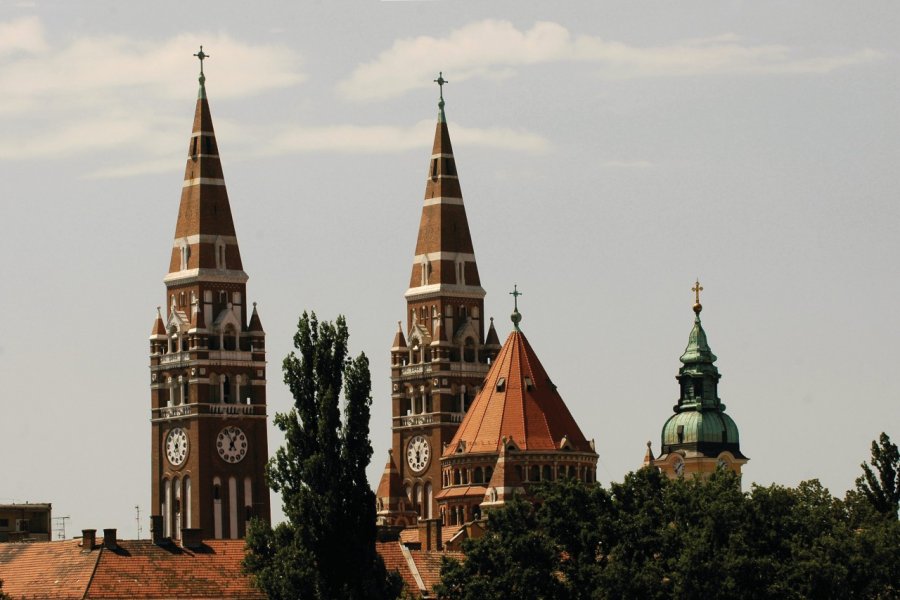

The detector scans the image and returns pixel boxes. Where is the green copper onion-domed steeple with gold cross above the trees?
[648,281,748,477]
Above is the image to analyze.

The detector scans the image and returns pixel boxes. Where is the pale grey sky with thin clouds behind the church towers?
[0,0,900,538]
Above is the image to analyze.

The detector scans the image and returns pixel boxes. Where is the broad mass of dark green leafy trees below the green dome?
[439,454,900,600]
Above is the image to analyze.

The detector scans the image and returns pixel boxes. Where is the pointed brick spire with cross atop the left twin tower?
[166,47,247,282]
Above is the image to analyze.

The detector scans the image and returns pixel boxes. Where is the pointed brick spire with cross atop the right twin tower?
[407,73,484,297]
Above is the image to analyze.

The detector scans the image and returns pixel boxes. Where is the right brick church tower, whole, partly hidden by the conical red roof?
[376,76,500,525]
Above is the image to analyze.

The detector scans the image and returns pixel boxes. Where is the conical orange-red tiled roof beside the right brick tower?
[443,331,593,456]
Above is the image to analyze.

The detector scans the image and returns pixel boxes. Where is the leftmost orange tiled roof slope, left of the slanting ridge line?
[0,540,100,600]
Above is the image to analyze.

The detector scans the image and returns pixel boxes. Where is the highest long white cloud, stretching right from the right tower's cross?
[338,20,883,100]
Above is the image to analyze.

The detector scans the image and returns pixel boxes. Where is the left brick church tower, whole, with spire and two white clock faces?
[150,47,270,539]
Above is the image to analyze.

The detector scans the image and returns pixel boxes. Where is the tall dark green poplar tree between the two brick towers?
[244,312,402,600]
